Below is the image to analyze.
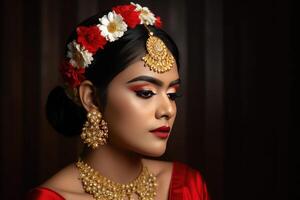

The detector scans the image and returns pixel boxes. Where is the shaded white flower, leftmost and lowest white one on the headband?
[67,40,93,68]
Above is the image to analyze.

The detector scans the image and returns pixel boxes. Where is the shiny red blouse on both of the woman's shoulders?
[27,162,209,200]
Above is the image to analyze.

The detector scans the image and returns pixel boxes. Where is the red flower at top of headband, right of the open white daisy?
[112,4,141,28]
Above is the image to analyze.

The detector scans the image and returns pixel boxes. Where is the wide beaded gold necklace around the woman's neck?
[76,159,157,200]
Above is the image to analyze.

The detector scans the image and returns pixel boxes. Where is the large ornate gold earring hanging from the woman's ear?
[80,110,108,149]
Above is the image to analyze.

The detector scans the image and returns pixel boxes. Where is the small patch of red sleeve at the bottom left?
[27,187,65,200]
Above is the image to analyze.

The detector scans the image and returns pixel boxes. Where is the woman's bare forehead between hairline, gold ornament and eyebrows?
[112,60,179,84]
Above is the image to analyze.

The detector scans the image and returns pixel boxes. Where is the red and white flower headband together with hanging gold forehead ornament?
[60,3,175,90]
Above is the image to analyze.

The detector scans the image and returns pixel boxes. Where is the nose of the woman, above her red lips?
[155,95,176,120]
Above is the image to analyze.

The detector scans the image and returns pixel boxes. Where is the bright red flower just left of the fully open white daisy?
[76,26,107,54]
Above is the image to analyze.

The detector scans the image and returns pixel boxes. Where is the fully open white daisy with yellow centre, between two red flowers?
[98,11,127,42]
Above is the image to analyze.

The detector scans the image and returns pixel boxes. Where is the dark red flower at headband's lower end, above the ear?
[59,60,85,88]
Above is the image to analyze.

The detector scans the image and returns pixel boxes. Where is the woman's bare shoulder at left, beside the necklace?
[33,163,91,199]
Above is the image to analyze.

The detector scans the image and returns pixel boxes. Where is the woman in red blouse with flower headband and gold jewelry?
[29,3,208,200]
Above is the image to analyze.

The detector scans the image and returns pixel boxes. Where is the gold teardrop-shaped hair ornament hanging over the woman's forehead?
[142,25,175,73]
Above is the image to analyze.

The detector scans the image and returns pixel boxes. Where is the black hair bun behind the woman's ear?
[46,86,86,136]
